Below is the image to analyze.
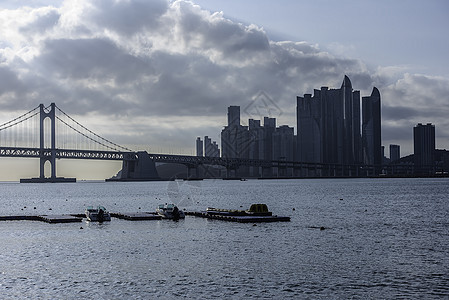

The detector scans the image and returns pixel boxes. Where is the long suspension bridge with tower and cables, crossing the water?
[0,103,412,182]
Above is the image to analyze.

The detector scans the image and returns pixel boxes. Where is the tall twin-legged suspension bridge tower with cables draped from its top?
[39,103,56,180]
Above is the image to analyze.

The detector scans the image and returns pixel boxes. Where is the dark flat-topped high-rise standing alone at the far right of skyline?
[413,123,435,173]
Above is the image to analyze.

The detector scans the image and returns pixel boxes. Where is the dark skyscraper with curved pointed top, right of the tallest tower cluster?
[362,87,383,166]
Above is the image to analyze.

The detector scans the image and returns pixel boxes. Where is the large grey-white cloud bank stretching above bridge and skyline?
[0,0,449,155]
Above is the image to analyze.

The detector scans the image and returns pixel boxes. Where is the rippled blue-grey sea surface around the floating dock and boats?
[0,179,449,299]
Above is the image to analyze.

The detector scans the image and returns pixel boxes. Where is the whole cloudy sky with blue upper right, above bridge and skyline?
[0,0,449,180]
